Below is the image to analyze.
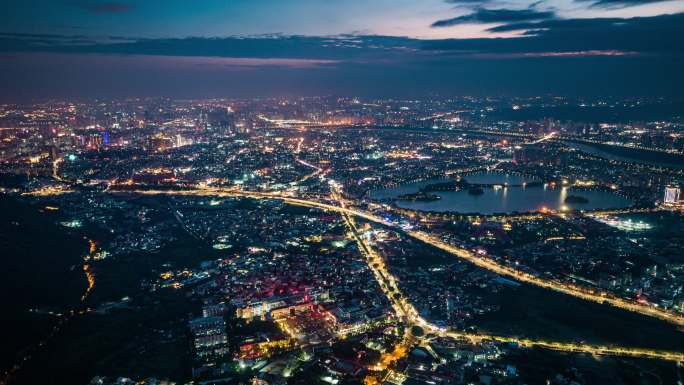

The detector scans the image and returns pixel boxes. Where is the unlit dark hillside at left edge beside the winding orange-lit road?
[0,195,87,372]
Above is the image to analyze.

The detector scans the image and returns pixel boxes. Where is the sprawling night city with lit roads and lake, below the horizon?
[0,96,684,385]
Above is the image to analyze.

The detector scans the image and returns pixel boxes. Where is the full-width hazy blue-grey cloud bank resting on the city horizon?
[0,36,684,102]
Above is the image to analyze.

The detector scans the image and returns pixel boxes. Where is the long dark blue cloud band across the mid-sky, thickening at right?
[0,11,684,62]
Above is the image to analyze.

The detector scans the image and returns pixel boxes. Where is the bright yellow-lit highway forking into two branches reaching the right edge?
[28,187,684,361]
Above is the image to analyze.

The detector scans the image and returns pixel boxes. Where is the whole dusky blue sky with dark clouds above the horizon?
[0,0,684,102]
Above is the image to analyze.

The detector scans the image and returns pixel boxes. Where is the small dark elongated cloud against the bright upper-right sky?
[432,8,555,28]
